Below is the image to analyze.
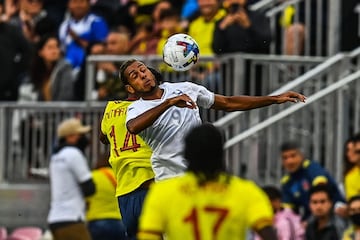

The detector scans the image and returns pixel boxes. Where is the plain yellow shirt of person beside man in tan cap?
[86,167,121,221]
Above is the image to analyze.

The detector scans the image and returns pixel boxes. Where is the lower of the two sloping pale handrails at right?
[224,70,360,149]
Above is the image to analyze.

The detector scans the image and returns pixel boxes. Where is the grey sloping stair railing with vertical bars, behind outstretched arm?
[215,48,360,183]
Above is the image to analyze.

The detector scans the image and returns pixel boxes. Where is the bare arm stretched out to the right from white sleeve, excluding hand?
[212,95,278,112]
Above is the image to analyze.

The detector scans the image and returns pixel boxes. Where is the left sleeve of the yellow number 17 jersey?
[137,183,166,240]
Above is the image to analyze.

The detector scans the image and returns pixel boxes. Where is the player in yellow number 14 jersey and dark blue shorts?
[100,97,154,239]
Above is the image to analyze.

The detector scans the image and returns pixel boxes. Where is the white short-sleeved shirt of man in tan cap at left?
[48,146,91,224]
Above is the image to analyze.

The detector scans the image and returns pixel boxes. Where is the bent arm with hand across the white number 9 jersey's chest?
[126,94,196,134]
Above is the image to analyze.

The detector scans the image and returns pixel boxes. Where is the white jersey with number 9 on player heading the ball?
[126,82,215,180]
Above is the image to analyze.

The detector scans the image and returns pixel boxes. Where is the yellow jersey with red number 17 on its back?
[138,173,273,240]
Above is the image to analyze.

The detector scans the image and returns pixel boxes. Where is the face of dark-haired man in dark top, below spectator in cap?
[309,192,332,218]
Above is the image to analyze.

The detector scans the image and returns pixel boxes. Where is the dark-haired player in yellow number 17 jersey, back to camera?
[137,124,276,240]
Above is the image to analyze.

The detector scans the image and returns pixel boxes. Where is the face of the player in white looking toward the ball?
[125,61,157,96]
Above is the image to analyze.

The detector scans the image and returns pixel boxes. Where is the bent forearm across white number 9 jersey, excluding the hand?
[126,100,172,134]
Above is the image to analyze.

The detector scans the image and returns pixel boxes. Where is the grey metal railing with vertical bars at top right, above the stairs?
[262,0,340,56]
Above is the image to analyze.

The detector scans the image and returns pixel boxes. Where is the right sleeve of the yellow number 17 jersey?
[246,183,273,231]
